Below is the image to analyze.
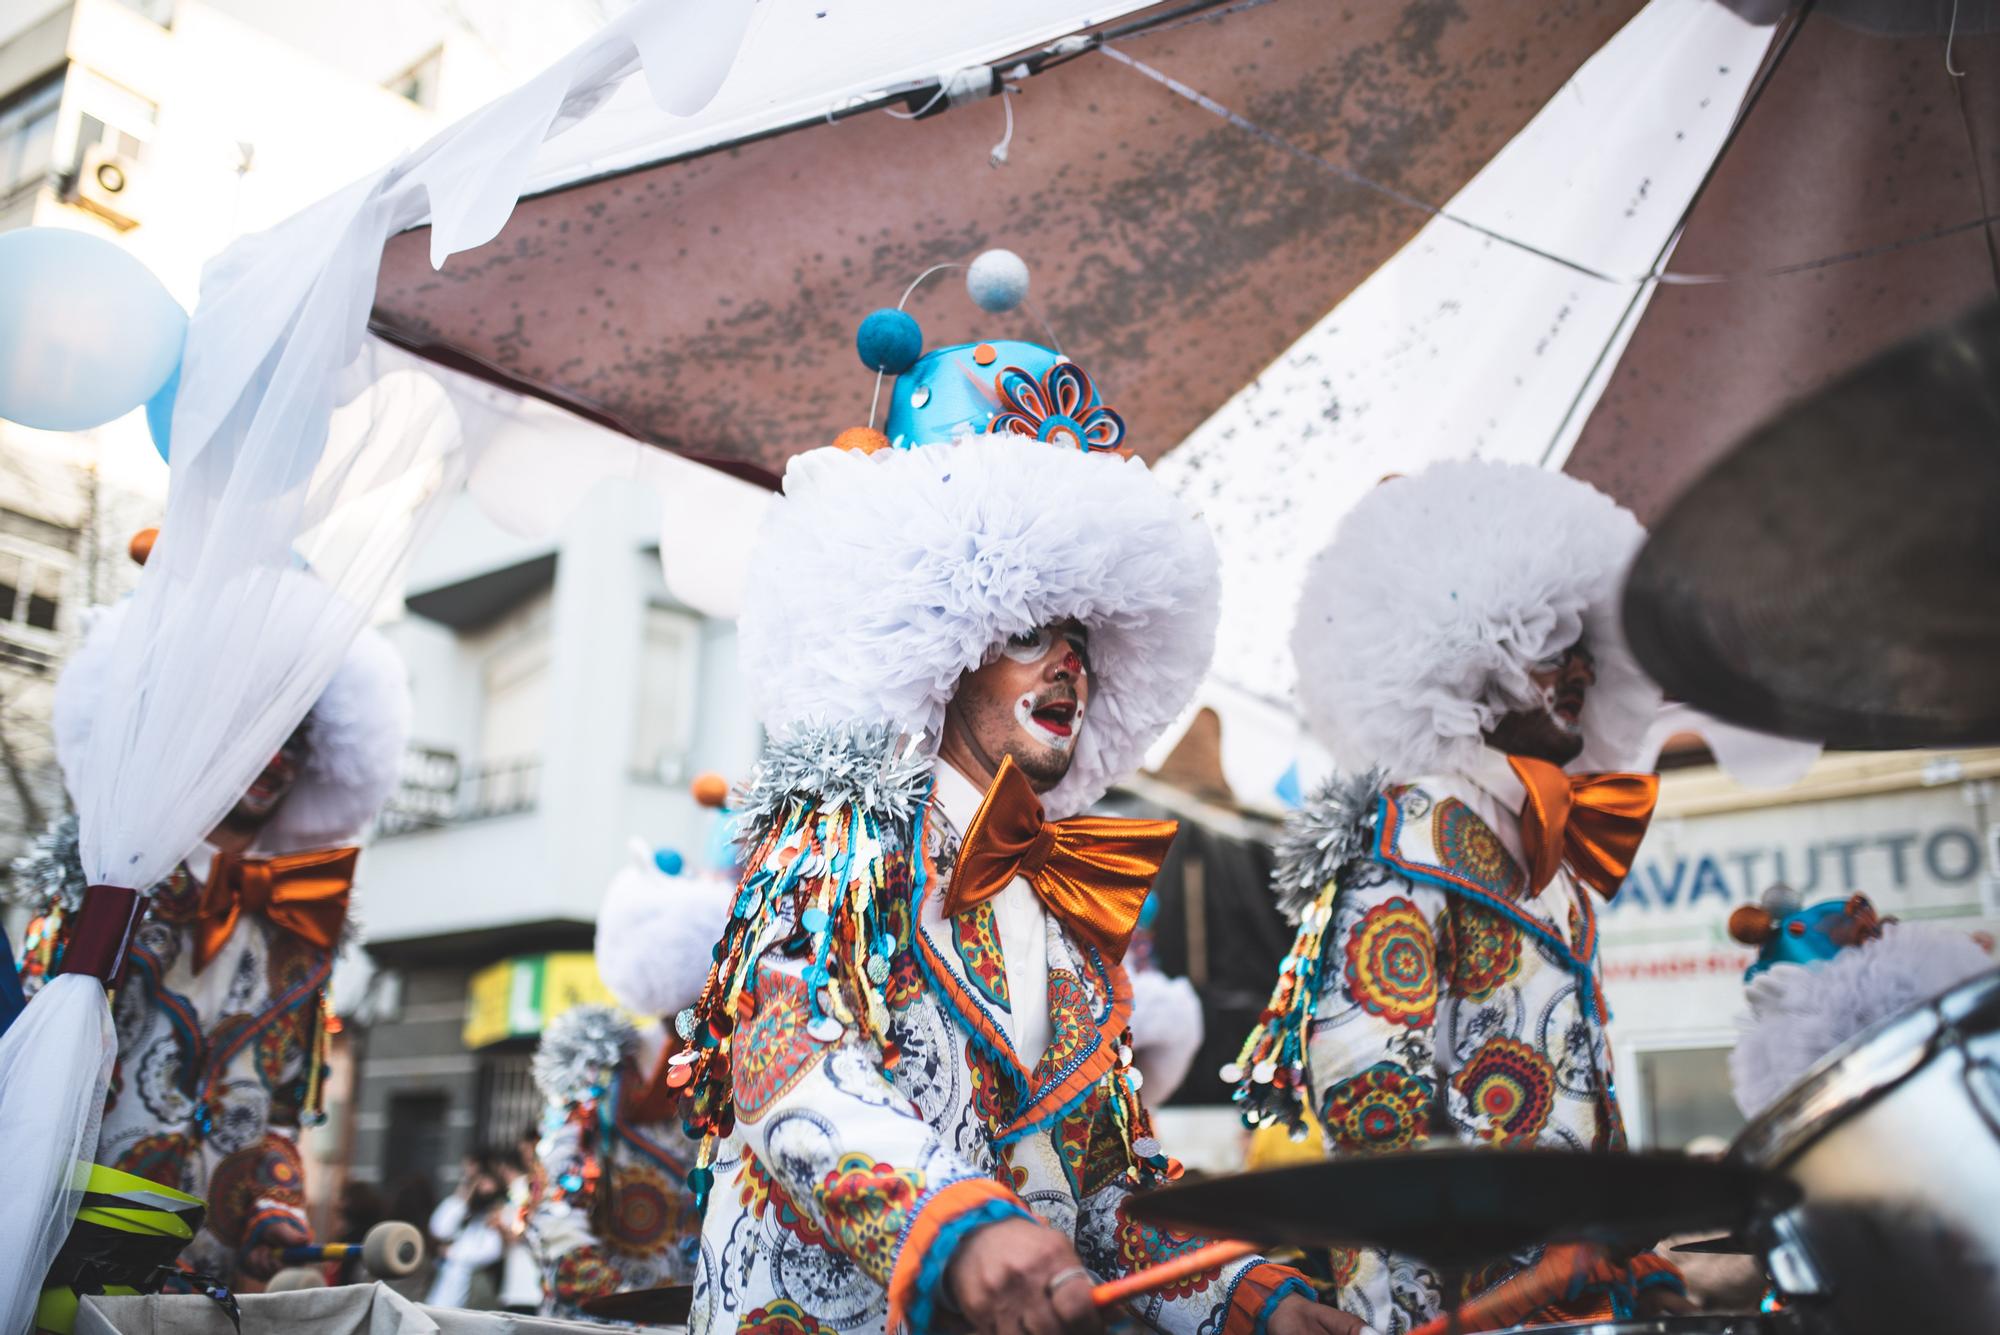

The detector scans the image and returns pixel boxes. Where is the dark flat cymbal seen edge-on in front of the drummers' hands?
[1126,1149,1798,1269]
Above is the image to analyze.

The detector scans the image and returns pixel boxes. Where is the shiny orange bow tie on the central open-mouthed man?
[944,755,1180,961]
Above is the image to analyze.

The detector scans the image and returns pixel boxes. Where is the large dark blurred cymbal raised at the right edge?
[1624,302,2000,749]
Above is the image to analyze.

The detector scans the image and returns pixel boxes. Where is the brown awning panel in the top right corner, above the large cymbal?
[1566,6,2000,520]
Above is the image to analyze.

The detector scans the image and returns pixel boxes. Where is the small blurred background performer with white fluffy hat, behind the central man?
[528,847,736,1319]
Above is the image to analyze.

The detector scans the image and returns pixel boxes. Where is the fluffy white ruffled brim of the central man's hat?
[738,436,1218,819]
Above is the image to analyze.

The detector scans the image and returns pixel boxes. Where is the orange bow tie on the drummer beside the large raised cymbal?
[1506,755,1660,901]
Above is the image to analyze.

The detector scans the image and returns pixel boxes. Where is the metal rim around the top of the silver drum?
[1730,969,2000,1167]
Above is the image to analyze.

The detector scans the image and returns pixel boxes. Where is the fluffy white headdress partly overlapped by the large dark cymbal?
[1292,460,1660,781]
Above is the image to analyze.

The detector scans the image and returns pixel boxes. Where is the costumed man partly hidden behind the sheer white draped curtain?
[14,544,410,1287]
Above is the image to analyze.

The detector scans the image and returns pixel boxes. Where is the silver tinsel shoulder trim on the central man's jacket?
[736,723,932,847]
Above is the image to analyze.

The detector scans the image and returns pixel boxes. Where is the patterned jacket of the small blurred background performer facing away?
[528,1007,700,1319]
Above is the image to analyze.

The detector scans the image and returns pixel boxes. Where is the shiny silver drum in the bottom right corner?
[1730,971,2000,1335]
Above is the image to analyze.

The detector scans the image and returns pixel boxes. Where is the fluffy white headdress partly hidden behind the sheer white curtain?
[54,595,410,853]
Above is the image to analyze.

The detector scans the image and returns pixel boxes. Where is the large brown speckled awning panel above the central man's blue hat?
[374,0,1640,474]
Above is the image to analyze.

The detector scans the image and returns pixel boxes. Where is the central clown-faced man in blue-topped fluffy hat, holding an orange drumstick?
[670,279,1356,1335]
